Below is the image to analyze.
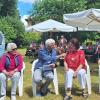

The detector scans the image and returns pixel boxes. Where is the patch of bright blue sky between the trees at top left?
[17,0,34,16]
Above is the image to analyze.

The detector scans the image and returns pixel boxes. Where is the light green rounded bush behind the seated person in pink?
[0,16,25,46]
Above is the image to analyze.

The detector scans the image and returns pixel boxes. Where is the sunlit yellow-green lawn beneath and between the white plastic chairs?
[6,49,100,100]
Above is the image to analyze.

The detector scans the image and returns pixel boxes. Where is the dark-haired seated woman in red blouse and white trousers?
[64,38,87,100]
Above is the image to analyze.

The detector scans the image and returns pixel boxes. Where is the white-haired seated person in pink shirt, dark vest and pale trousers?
[0,43,23,100]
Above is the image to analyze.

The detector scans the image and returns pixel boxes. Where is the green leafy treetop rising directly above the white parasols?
[32,0,86,21]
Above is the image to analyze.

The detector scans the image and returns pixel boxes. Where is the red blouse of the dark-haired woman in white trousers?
[64,50,86,70]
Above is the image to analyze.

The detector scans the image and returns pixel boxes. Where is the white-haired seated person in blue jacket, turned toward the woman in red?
[33,38,56,96]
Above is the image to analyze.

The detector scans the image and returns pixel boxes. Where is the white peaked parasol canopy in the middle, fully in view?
[26,19,76,32]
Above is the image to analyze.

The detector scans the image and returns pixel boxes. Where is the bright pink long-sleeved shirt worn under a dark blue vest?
[0,53,23,72]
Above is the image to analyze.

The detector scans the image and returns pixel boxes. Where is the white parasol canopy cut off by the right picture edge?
[63,8,100,31]
